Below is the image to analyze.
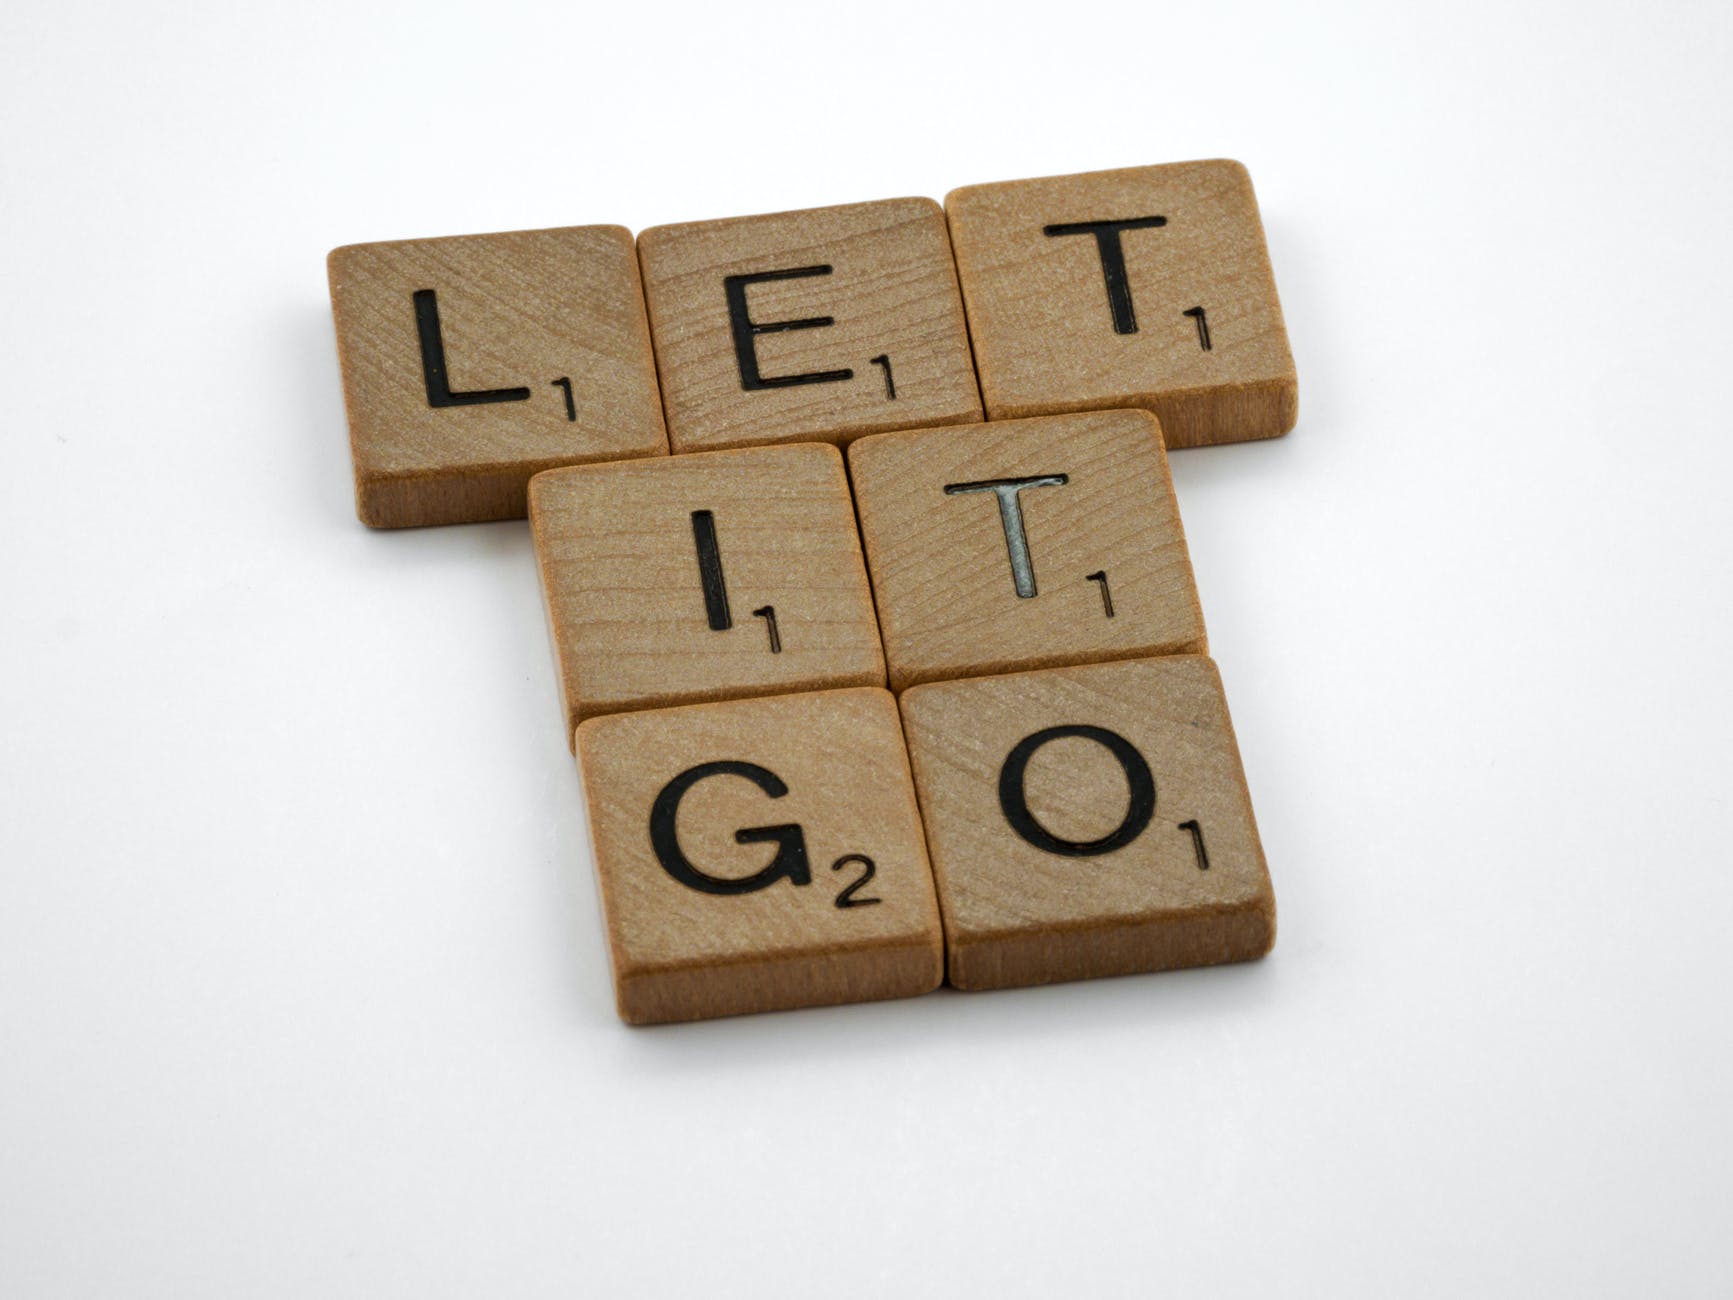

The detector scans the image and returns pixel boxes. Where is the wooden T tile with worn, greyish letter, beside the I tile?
[849,411,1206,690]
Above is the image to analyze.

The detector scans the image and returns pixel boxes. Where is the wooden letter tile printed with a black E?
[638,199,981,452]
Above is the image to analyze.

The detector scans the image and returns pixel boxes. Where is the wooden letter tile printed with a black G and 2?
[577,690,944,1024]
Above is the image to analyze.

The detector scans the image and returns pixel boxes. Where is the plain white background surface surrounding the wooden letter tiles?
[0,0,1733,1300]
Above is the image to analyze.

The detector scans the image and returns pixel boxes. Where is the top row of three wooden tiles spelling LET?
[331,163,1296,525]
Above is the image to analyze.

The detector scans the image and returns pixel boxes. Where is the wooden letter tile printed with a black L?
[329,225,667,529]
